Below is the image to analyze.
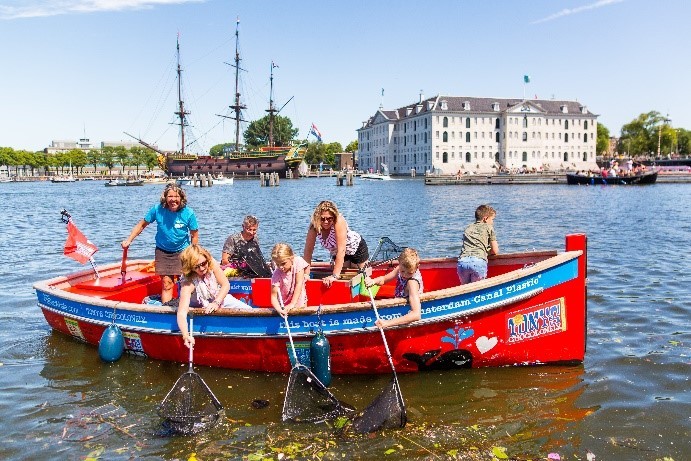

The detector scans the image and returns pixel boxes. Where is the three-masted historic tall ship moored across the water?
[125,20,307,178]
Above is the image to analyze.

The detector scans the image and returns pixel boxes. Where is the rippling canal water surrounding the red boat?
[0,178,691,461]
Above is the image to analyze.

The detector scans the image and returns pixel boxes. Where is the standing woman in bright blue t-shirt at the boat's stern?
[121,183,199,304]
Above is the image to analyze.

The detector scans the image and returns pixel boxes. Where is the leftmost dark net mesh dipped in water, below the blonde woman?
[158,370,223,435]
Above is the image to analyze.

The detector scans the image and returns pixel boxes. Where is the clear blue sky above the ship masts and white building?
[0,0,691,153]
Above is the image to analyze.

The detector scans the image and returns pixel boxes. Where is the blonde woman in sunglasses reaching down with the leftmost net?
[177,243,252,347]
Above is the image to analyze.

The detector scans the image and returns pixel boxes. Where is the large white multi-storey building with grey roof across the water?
[357,95,597,174]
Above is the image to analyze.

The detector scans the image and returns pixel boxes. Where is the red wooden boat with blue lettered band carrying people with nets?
[34,234,587,374]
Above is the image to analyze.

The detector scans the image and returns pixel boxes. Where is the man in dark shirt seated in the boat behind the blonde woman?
[221,215,271,277]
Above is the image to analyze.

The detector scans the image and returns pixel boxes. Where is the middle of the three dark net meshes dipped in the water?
[283,364,354,423]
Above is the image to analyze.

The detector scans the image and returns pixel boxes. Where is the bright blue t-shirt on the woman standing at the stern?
[144,203,199,253]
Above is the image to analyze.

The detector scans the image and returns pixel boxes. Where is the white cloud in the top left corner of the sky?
[0,0,206,19]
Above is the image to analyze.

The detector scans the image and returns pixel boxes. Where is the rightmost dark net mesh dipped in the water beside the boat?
[353,375,408,434]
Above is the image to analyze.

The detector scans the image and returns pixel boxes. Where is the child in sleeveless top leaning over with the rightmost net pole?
[365,248,424,328]
